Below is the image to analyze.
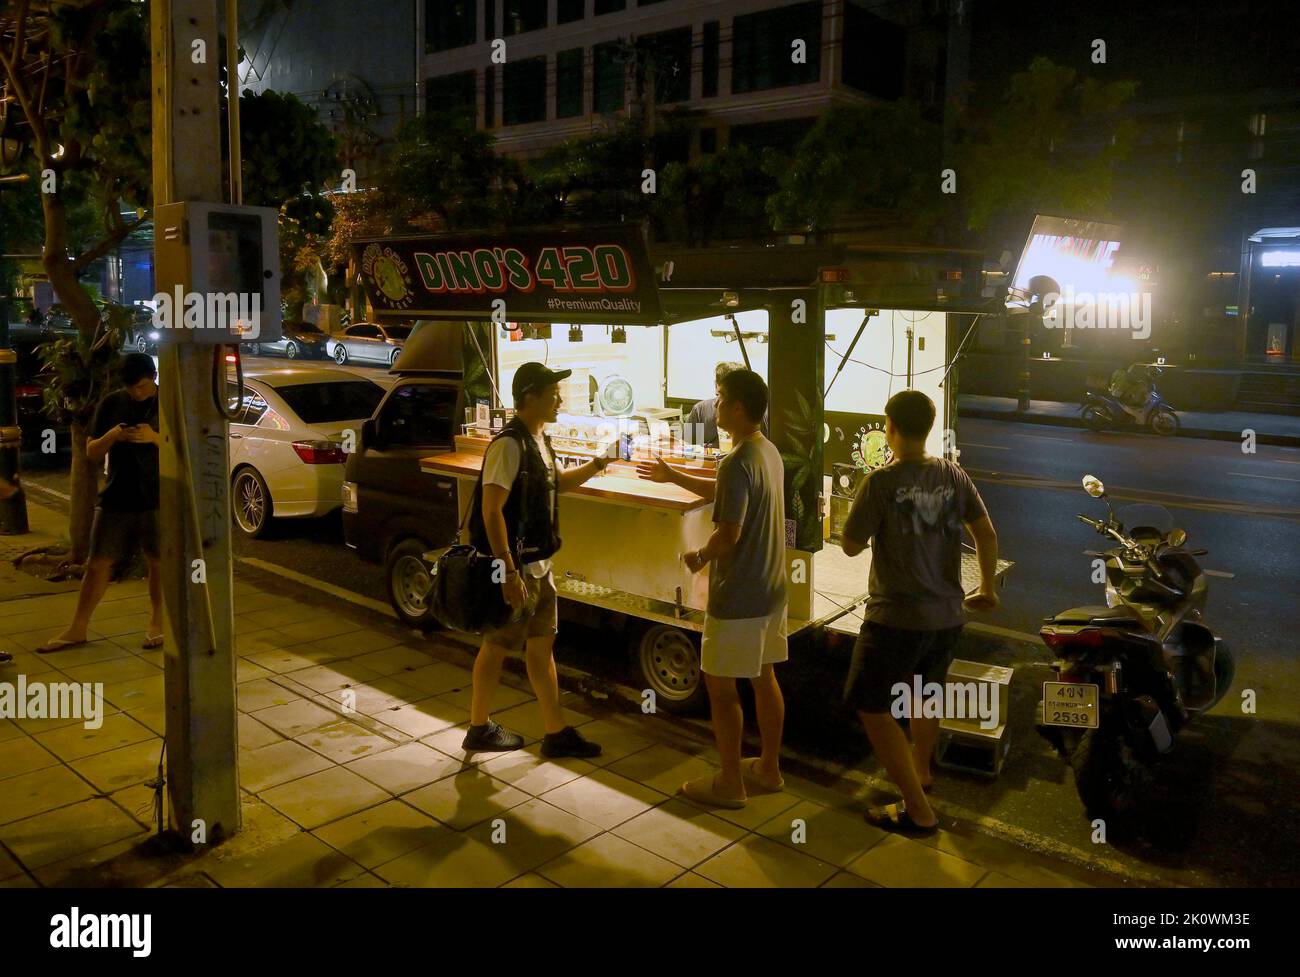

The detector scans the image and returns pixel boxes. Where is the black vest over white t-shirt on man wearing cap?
[469,417,560,569]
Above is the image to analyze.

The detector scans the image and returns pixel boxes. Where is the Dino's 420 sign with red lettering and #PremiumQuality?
[354,226,660,324]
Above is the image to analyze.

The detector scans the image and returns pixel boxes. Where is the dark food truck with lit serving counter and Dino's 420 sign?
[343,225,1009,711]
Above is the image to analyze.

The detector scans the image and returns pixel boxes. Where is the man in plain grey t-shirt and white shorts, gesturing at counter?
[638,370,787,808]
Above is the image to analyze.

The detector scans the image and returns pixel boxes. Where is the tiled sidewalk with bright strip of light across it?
[0,519,1113,887]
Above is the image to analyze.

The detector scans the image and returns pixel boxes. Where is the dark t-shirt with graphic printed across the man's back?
[844,457,987,631]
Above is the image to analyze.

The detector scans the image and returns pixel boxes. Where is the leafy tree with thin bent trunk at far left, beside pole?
[0,0,152,563]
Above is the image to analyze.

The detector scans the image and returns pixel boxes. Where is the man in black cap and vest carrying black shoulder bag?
[460,362,612,757]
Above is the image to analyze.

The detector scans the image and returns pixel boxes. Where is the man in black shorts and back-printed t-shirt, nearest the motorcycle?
[844,390,997,834]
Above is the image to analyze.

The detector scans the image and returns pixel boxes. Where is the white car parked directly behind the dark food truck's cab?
[230,366,384,538]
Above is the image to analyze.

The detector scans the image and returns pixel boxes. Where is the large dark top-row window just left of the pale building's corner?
[732,0,822,95]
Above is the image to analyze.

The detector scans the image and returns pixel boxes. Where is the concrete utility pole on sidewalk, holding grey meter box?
[150,0,239,843]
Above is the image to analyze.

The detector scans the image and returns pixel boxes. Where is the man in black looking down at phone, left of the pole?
[36,353,163,653]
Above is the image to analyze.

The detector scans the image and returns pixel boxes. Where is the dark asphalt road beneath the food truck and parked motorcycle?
[12,361,1300,886]
